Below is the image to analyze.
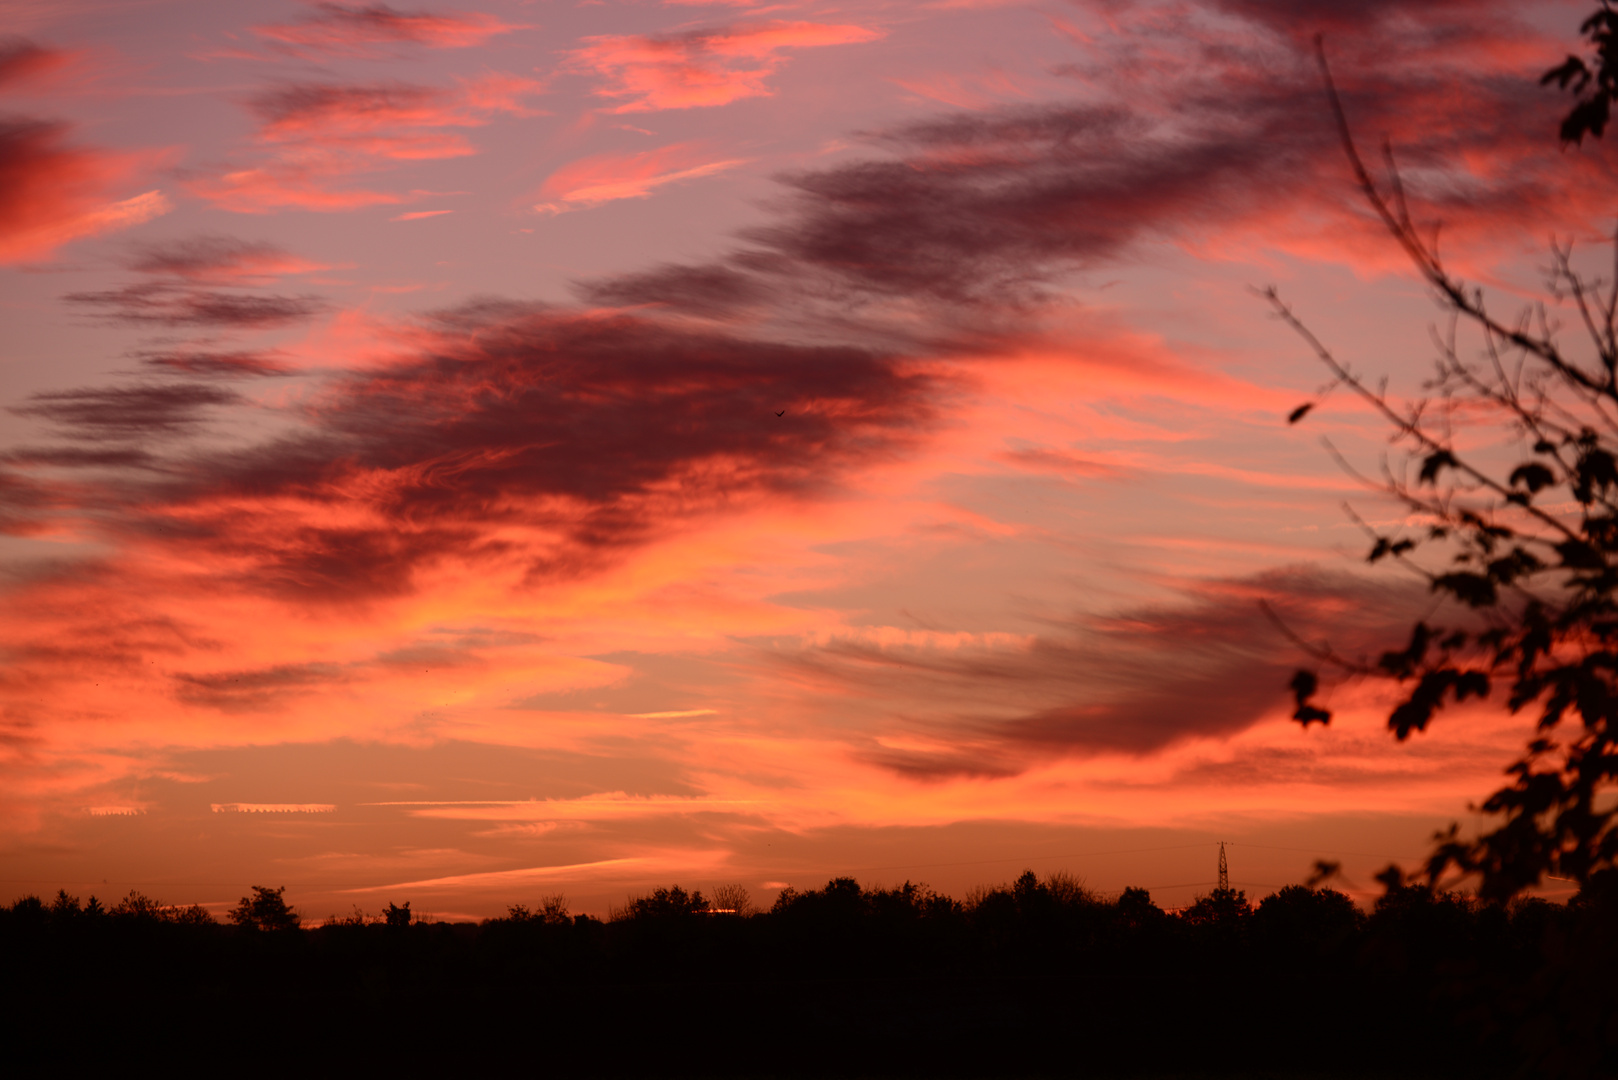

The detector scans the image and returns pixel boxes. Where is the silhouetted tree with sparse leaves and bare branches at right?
[1265,25,1618,899]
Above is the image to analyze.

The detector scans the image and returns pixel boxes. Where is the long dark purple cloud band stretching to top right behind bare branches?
[581,2,1618,340]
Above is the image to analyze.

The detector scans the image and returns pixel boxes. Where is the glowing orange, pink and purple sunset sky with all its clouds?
[0,0,1613,918]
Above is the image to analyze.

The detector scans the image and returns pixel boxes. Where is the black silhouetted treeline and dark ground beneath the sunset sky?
[0,871,1618,1077]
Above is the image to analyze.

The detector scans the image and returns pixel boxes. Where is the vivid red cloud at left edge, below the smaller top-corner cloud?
[0,120,172,264]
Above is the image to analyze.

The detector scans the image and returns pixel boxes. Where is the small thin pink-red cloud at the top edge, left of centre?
[252,3,526,57]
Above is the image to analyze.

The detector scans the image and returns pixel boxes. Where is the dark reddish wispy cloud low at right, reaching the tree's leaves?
[773,567,1443,780]
